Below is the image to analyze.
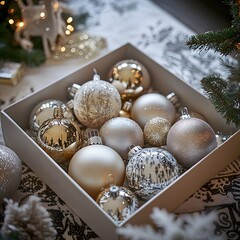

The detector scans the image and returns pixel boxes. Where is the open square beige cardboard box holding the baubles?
[1,44,240,240]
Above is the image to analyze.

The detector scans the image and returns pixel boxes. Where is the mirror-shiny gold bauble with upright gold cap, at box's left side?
[37,107,82,163]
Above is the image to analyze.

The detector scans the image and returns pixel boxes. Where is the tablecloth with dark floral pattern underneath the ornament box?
[0,0,240,239]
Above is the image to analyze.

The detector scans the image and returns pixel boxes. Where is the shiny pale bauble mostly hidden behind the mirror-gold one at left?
[30,99,74,132]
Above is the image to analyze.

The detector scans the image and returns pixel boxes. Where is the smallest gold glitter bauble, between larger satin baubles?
[143,117,171,147]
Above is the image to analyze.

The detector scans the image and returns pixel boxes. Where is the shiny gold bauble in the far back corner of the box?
[109,59,151,101]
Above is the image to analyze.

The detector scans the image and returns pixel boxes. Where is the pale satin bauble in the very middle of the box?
[99,117,144,161]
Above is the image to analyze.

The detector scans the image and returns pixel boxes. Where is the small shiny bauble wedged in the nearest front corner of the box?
[96,185,139,223]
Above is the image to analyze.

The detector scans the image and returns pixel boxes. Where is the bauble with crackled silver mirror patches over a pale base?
[126,146,183,200]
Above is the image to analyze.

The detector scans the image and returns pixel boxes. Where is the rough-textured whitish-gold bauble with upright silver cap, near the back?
[74,70,122,128]
